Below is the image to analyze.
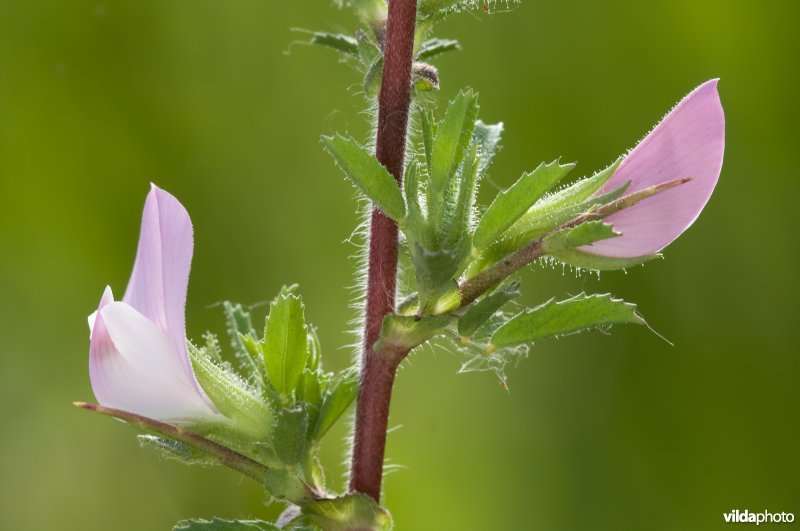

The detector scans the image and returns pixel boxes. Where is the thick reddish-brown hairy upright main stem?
[350,0,417,501]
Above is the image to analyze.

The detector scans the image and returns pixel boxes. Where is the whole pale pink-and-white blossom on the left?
[89,185,219,421]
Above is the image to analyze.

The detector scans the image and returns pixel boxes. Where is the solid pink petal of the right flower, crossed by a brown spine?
[581,79,725,258]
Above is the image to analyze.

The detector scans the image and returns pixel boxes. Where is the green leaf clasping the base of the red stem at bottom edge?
[300,494,392,531]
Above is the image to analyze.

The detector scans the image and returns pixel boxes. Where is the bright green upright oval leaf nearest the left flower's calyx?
[263,294,308,396]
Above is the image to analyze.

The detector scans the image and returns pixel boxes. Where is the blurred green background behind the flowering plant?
[0,0,800,531]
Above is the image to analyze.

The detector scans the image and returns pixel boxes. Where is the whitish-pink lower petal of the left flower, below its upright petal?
[89,302,218,421]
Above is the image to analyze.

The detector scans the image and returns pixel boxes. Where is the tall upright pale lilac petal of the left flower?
[122,185,200,391]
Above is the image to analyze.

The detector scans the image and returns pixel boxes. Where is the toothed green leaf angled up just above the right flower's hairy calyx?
[472,161,575,249]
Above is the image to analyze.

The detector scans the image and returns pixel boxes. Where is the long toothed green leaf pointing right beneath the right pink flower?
[491,294,645,347]
